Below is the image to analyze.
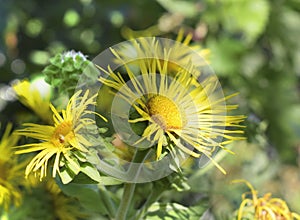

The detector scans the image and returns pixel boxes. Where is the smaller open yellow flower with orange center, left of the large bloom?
[16,91,102,179]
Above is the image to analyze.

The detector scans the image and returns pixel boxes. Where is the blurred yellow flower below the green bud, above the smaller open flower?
[12,80,52,122]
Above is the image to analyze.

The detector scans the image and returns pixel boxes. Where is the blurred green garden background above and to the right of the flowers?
[0,0,300,218]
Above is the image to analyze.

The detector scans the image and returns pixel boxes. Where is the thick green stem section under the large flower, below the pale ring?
[116,183,136,220]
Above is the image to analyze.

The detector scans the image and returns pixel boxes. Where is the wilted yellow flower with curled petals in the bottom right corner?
[233,179,300,220]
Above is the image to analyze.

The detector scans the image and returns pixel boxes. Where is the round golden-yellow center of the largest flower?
[147,95,183,130]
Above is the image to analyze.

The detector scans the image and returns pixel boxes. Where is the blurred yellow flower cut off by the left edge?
[0,124,25,211]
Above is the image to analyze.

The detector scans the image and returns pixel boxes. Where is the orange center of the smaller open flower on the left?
[52,121,75,147]
